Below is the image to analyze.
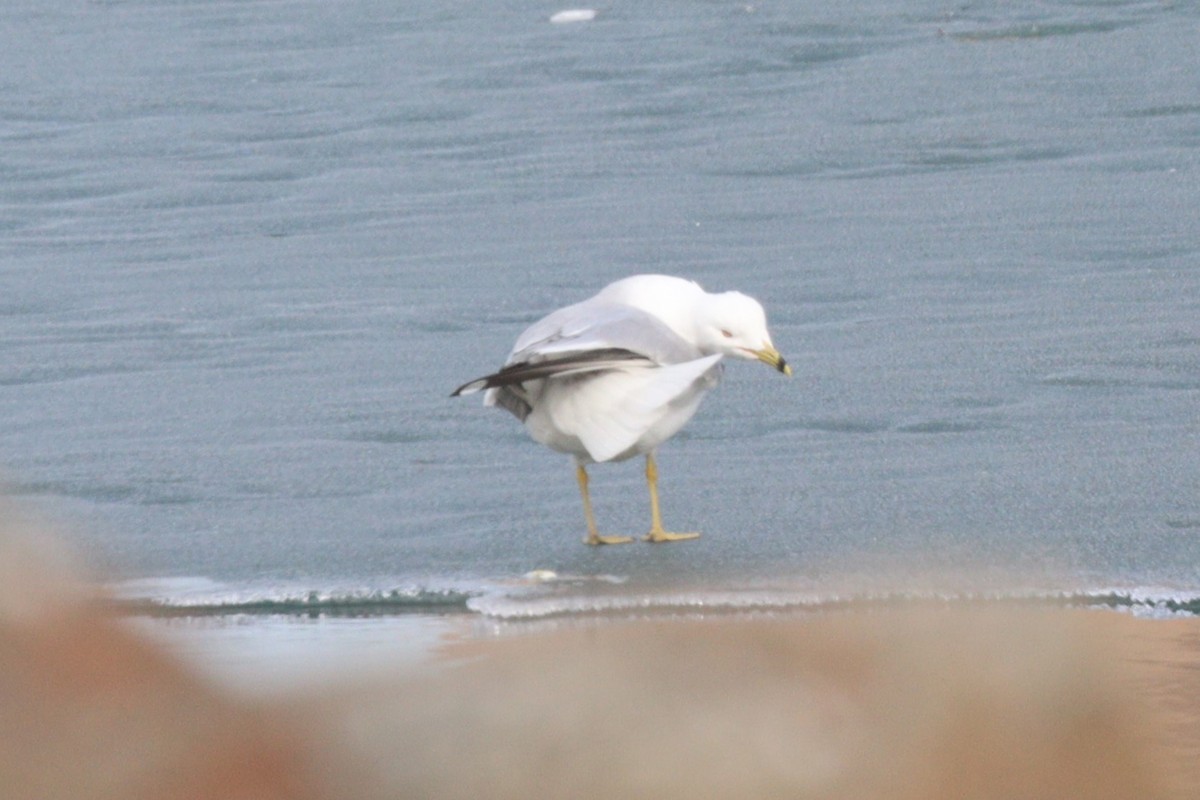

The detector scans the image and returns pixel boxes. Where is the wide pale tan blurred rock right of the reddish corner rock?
[333,609,1168,800]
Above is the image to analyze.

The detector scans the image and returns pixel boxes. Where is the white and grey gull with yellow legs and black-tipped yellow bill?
[451,275,792,545]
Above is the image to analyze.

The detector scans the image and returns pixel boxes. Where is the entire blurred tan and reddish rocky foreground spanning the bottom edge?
[0,510,1200,800]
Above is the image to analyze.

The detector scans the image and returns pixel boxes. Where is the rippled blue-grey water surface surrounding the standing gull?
[0,0,1200,615]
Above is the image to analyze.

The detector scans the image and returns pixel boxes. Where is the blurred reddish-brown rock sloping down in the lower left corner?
[0,513,334,800]
